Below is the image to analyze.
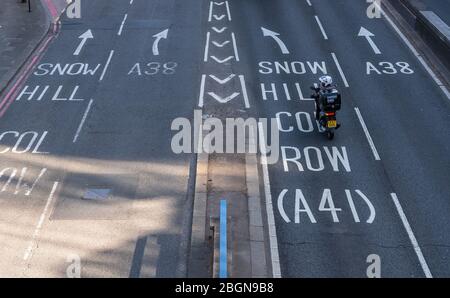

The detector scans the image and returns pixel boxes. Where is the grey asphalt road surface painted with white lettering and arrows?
[0,0,450,277]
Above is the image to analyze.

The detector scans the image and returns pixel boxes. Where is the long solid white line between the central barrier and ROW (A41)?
[258,122,281,278]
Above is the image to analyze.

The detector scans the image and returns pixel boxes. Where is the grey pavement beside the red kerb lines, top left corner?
[0,0,48,92]
